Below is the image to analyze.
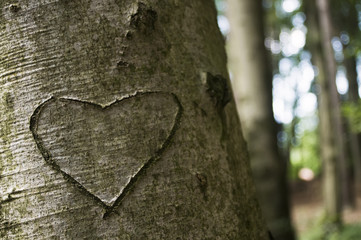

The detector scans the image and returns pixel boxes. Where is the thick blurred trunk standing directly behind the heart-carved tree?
[228,0,294,240]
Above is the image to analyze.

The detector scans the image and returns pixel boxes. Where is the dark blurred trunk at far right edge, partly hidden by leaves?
[324,0,361,208]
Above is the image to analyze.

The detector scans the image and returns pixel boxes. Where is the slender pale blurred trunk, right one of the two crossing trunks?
[316,0,346,230]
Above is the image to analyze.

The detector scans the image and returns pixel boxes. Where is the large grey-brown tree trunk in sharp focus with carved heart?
[0,0,267,240]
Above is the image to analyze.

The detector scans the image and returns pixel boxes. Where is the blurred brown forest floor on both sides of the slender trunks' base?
[291,179,361,239]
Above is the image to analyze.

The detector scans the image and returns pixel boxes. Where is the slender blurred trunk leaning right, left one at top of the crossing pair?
[304,0,342,233]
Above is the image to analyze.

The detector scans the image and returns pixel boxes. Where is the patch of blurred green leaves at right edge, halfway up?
[342,100,361,133]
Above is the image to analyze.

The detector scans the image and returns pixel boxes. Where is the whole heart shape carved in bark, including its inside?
[30,92,181,214]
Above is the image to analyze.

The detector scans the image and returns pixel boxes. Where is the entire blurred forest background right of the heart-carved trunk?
[216,0,361,240]
